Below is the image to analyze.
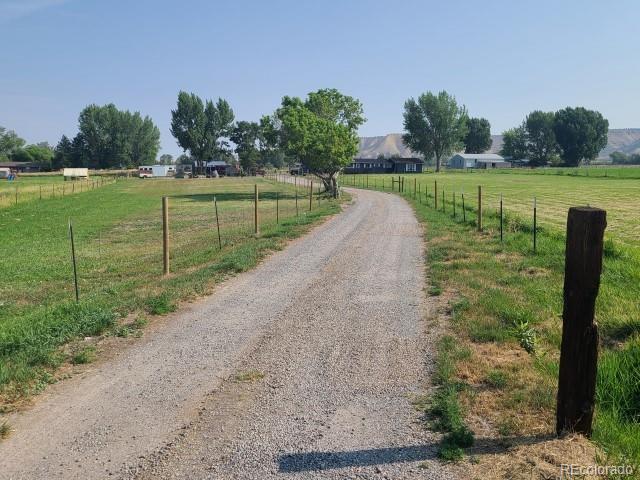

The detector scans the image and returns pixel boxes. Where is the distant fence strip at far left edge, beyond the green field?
[0,177,116,208]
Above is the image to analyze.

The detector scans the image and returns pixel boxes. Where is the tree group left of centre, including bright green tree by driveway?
[171,89,365,195]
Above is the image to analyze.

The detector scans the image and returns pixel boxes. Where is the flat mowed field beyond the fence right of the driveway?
[343,168,640,246]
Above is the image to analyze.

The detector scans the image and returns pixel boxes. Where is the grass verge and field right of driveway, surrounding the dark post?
[343,172,640,466]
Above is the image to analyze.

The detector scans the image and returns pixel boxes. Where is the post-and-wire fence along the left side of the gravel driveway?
[8,176,332,304]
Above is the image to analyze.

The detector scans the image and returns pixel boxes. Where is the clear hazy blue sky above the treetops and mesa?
[0,0,640,155]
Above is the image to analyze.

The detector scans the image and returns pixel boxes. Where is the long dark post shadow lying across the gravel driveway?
[279,444,437,473]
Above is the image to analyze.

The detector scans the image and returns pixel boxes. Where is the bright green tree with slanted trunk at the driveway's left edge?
[276,89,365,196]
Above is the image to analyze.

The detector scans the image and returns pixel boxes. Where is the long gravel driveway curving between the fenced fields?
[0,191,454,480]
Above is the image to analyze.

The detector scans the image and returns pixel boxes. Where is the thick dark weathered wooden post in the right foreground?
[556,207,607,436]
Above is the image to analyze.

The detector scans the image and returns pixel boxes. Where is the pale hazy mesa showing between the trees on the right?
[358,128,640,158]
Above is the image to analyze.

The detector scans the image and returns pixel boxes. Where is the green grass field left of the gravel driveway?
[0,178,339,404]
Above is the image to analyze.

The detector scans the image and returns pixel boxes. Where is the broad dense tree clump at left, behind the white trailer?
[52,103,160,169]
